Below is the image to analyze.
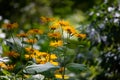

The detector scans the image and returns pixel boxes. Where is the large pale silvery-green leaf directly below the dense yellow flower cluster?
[23,62,58,74]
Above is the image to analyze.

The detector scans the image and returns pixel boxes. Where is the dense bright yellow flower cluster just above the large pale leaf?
[25,48,58,66]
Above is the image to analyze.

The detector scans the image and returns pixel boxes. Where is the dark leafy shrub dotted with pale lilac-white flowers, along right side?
[88,0,120,80]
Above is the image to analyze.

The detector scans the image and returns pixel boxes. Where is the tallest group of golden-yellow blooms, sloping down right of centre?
[48,20,86,47]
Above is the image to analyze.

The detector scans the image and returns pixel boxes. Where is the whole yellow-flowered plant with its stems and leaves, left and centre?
[0,17,87,80]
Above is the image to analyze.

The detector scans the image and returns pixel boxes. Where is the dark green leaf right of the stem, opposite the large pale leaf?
[67,63,87,73]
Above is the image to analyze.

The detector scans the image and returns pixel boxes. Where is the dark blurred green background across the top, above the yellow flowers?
[0,0,103,23]
